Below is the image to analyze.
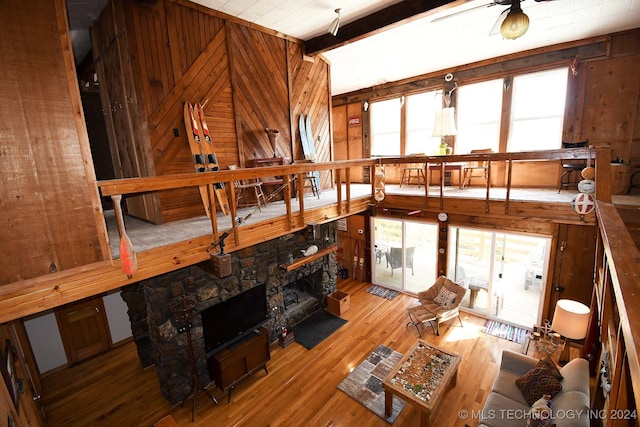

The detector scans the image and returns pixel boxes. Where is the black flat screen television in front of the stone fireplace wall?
[200,283,269,355]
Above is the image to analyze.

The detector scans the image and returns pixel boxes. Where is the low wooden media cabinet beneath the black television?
[207,327,271,403]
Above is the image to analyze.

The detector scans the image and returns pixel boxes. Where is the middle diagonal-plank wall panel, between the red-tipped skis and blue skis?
[227,22,292,166]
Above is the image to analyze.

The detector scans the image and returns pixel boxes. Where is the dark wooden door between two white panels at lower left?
[56,297,111,365]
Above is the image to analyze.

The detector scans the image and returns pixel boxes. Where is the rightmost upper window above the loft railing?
[507,68,568,151]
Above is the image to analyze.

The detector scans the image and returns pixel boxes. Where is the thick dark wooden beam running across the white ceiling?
[304,0,465,55]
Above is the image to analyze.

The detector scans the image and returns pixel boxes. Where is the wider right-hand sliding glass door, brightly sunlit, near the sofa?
[448,227,551,328]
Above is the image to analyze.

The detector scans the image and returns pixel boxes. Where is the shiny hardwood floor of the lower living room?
[42,280,520,427]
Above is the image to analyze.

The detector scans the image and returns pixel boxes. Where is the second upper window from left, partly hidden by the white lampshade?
[405,91,442,156]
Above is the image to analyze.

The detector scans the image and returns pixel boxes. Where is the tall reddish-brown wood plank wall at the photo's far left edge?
[0,0,109,285]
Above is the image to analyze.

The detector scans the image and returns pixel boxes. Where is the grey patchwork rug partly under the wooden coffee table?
[338,344,406,424]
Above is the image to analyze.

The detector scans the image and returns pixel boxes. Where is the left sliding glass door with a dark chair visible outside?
[371,218,438,294]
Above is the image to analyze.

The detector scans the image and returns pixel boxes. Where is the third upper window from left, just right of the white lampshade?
[454,79,502,154]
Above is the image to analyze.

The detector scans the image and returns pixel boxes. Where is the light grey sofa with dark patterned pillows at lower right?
[479,350,589,427]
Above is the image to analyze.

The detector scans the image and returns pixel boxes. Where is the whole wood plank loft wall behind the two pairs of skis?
[94,0,331,223]
